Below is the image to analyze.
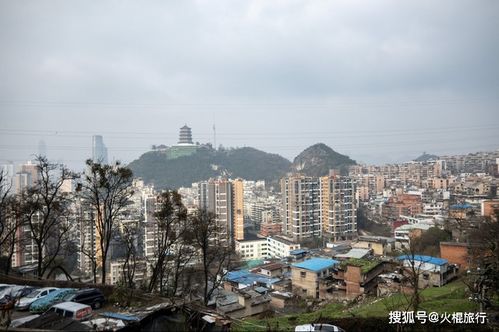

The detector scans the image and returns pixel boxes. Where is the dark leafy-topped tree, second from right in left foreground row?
[148,191,187,293]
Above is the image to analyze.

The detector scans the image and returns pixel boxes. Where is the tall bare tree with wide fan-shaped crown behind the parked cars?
[81,159,133,284]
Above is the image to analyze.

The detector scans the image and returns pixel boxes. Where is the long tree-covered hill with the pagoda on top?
[128,146,291,189]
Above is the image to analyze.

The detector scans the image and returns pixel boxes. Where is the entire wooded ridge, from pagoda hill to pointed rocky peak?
[128,143,355,189]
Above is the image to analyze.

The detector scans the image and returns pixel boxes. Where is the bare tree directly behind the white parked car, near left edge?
[20,156,77,279]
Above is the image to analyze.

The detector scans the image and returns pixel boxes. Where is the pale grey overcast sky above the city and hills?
[0,0,499,168]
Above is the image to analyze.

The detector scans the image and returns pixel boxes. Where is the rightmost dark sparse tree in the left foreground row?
[191,209,234,305]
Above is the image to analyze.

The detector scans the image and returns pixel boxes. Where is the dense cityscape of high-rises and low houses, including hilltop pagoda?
[0,126,499,330]
